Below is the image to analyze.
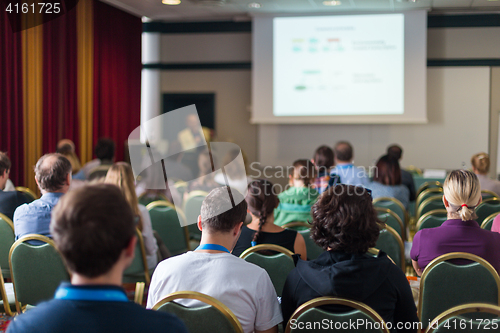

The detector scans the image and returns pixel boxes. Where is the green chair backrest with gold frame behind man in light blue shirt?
[9,234,70,313]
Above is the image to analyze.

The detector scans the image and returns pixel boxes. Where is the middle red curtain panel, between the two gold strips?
[42,8,80,155]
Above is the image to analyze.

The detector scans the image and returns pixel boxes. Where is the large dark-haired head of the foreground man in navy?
[50,184,135,278]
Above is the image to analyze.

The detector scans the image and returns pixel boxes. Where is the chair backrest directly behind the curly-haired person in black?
[285,296,389,333]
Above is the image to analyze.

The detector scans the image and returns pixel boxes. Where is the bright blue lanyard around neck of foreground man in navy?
[54,286,128,302]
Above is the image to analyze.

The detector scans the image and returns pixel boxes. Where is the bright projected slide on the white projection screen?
[272,13,405,117]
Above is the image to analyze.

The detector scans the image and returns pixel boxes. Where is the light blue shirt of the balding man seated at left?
[14,193,64,241]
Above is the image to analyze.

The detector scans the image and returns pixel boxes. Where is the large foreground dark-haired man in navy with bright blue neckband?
[8,184,187,333]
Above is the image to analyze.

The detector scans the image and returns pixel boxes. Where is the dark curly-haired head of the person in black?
[311,184,380,253]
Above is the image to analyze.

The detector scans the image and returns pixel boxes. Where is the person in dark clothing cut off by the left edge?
[0,152,29,220]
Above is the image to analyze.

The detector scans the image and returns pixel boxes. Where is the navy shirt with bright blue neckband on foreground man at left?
[7,283,187,333]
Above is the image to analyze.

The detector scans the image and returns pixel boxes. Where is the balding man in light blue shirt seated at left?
[14,153,71,244]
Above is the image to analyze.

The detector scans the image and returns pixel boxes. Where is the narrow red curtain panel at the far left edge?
[0,11,24,186]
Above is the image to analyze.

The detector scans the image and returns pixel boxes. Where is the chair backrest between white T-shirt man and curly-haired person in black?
[240,244,295,296]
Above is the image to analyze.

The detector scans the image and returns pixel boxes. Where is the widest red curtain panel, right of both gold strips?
[93,1,142,161]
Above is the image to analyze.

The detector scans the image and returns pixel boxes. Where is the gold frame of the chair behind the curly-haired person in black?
[285,296,389,333]
